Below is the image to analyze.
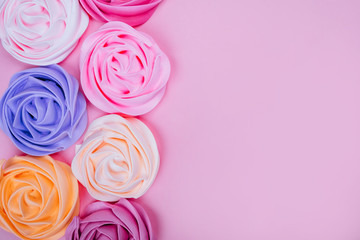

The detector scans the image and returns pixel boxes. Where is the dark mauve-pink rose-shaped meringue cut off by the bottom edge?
[65,199,153,240]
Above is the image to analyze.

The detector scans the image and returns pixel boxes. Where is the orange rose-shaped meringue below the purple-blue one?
[0,156,79,240]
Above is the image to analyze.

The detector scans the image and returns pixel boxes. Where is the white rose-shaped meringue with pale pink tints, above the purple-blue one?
[0,0,89,66]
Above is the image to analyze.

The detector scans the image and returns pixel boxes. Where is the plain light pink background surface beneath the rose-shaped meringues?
[0,0,360,240]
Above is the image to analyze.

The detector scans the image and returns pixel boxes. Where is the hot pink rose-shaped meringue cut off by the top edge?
[80,0,161,26]
